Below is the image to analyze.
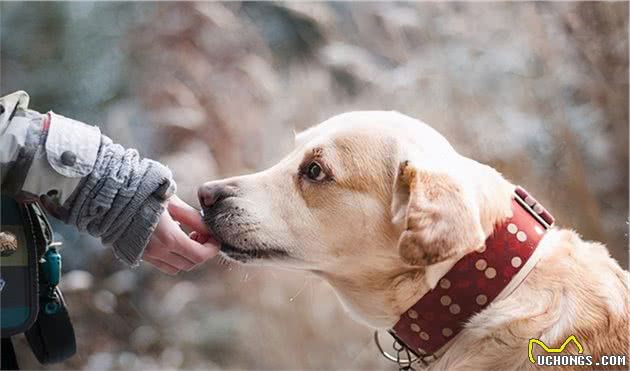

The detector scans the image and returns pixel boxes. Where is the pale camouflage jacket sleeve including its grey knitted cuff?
[0,91,175,265]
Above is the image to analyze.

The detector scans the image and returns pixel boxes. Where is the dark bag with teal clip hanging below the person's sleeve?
[0,196,76,368]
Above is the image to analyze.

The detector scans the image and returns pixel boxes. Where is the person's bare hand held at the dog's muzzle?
[143,196,219,275]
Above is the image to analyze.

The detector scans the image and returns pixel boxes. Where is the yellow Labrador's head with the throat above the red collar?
[199,111,509,323]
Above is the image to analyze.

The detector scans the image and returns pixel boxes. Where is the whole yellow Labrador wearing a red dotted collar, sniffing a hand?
[199,111,629,370]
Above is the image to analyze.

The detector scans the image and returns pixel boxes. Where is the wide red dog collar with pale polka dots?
[390,187,554,361]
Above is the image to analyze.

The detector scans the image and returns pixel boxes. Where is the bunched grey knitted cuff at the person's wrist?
[63,136,175,266]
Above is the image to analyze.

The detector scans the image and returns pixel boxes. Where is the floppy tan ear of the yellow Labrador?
[392,161,485,266]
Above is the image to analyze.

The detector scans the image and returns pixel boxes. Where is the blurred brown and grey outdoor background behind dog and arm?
[0,2,628,370]
